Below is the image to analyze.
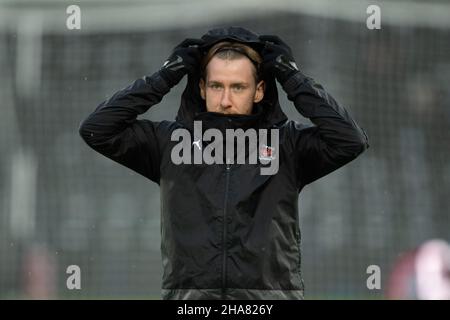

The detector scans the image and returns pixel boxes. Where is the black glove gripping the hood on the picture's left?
[160,39,204,87]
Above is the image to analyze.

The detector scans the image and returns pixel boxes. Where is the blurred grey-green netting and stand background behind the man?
[0,0,450,299]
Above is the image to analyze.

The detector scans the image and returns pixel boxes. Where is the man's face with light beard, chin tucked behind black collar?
[200,56,264,114]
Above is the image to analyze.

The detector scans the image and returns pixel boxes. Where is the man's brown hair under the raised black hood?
[201,42,262,83]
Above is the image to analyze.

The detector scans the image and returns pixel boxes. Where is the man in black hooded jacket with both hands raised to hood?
[80,27,368,299]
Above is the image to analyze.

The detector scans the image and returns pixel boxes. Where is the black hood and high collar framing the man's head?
[176,26,287,128]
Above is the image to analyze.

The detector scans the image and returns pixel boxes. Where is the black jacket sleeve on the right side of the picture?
[283,72,369,187]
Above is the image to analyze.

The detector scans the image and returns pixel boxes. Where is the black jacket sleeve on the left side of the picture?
[79,72,170,183]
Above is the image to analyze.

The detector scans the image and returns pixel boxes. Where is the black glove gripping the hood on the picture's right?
[259,35,299,85]
